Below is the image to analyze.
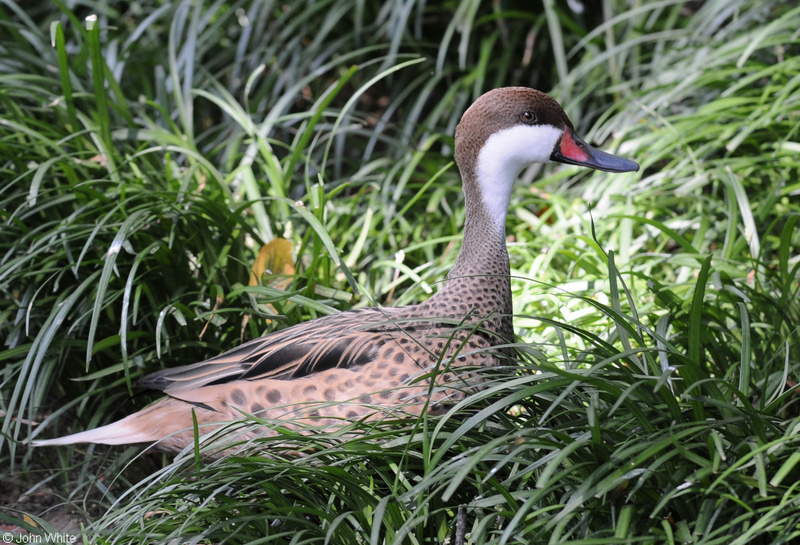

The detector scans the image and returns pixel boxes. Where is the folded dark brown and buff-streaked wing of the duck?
[137,308,416,392]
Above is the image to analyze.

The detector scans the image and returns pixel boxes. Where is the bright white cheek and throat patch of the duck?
[476,125,562,229]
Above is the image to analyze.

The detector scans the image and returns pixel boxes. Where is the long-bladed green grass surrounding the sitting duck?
[0,0,800,544]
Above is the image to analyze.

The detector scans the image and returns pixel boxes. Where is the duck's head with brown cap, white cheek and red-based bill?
[455,87,639,223]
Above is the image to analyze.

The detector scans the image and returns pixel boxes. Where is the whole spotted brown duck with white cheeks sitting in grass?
[32,87,639,452]
